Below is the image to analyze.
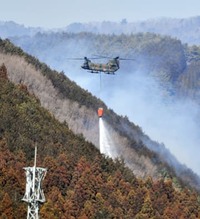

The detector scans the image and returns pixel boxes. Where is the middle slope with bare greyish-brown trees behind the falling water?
[0,36,199,192]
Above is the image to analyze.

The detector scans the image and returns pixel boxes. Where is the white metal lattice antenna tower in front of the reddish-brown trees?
[22,146,47,219]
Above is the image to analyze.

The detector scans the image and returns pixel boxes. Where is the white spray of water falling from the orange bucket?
[99,117,116,158]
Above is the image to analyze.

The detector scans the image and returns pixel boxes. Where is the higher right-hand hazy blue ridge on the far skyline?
[64,16,200,45]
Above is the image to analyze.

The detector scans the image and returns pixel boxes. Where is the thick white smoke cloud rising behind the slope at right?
[99,72,200,175]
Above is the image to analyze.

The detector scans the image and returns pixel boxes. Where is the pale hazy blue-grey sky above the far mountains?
[0,0,200,28]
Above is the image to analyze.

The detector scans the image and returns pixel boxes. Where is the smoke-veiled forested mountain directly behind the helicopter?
[7,32,200,173]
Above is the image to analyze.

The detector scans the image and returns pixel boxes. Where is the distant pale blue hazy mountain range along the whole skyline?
[0,16,200,45]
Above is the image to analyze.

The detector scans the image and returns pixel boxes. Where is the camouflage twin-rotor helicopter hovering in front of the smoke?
[68,56,133,75]
